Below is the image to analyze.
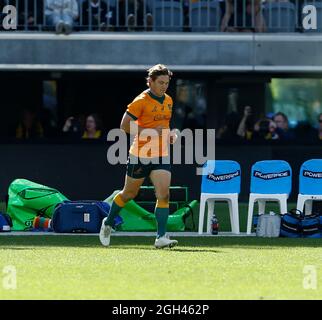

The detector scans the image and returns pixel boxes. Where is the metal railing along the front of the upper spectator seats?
[0,0,322,32]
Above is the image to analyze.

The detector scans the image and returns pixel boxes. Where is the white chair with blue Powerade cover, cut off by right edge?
[296,159,322,215]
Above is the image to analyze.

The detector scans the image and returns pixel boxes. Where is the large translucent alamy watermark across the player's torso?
[107,125,216,175]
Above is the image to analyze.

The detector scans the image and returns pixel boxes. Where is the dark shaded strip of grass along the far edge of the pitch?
[0,235,322,252]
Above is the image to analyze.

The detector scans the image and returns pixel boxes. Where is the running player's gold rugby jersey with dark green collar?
[126,89,173,158]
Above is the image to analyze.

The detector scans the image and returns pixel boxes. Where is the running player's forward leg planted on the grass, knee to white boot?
[150,169,178,248]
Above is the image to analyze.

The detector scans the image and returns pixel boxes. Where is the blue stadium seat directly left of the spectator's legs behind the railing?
[190,0,221,32]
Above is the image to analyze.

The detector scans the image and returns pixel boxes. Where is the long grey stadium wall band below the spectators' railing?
[0,32,322,73]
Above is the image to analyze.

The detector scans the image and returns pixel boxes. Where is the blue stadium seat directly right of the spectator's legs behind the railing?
[263,2,297,32]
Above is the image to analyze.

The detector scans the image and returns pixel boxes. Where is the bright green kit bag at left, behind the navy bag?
[7,179,68,231]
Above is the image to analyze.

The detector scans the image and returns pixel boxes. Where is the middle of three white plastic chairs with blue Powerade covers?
[247,160,292,234]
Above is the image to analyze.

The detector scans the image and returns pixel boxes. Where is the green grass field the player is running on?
[0,205,322,300]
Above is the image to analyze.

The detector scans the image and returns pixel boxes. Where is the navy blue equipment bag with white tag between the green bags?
[52,200,110,233]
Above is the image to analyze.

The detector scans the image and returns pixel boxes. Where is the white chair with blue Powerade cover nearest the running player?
[198,160,241,234]
